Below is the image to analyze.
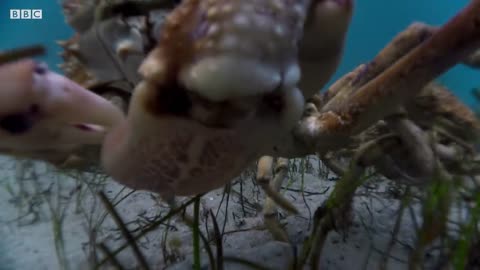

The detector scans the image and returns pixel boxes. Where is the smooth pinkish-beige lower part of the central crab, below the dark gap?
[102,83,290,196]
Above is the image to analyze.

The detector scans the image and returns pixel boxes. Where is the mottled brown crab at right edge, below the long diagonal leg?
[352,82,480,185]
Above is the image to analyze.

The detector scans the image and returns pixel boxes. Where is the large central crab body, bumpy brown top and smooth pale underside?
[102,0,312,199]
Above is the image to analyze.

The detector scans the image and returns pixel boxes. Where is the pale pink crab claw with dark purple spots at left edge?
[0,60,124,160]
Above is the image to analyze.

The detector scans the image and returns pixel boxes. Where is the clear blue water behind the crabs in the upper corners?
[0,0,480,106]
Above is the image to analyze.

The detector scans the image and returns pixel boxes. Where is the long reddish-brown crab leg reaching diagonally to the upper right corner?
[295,0,480,153]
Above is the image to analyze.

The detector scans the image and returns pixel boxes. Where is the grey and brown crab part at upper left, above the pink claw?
[57,0,170,112]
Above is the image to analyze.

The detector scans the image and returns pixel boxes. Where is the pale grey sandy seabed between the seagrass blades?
[0,157,462,270]
